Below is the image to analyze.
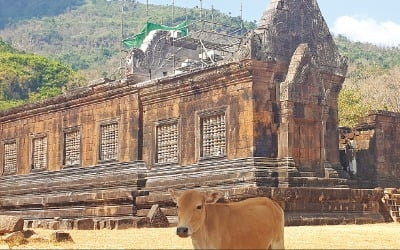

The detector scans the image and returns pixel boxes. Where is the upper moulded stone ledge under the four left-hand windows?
[0,162,145,197]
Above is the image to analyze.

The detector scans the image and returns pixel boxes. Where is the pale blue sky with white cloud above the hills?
[139,0,400,46]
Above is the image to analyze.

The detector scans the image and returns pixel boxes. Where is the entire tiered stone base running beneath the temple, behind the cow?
[0,158,385,229]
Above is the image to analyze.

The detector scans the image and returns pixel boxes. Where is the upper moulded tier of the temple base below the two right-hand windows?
[144,157,352,192]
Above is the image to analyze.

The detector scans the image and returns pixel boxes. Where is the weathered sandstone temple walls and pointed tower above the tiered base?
[0,0,347,181]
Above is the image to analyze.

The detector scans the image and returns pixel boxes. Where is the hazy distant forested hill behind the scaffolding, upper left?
[0,0,255,79]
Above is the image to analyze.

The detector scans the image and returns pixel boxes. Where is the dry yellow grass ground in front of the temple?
[0,223,400,249]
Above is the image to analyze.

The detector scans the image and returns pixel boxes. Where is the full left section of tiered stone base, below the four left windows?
[0,162,145,220]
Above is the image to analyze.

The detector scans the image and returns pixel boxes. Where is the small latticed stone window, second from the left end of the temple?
[31,135,48,170]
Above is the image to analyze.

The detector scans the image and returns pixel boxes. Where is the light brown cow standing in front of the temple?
[169,189,284,249]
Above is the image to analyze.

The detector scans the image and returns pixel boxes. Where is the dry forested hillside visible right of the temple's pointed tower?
[335,36,400,127]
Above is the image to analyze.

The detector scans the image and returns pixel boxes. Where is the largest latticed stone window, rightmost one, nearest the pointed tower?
[200,109,226,159]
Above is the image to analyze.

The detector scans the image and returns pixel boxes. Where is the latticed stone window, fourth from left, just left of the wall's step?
[99,122,119,161]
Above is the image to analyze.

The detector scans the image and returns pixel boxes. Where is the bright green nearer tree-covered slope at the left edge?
[0,41,85,109]
